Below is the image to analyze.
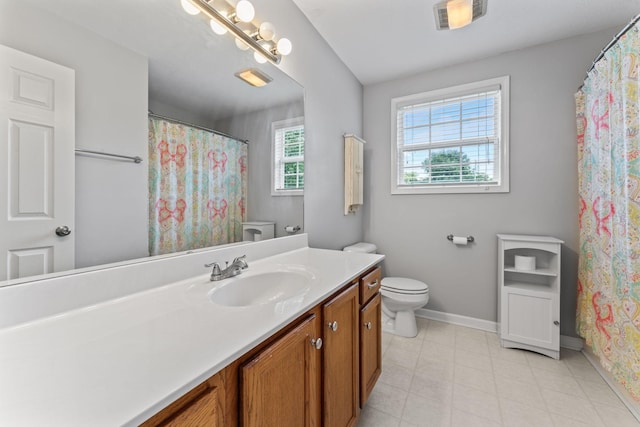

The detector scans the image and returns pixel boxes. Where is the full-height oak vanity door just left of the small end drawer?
[322,284,359,427]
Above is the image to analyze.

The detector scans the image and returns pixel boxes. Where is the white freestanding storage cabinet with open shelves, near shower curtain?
[498,234,564,359]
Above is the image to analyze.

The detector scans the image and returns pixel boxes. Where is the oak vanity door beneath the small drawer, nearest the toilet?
[360,294,382,408]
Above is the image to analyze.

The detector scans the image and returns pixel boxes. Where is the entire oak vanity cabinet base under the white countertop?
[142,268,382,427]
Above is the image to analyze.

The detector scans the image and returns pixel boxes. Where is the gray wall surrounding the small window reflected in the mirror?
[216,102,304,237]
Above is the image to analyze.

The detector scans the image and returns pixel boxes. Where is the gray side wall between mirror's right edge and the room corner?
[266,0,363,249]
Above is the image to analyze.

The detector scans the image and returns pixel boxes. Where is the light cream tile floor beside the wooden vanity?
[358,319,640,427]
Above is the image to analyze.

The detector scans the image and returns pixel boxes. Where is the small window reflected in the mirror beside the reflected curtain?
[271,117,304,196]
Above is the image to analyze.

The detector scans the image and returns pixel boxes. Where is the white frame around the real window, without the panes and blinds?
[391,75,509,194]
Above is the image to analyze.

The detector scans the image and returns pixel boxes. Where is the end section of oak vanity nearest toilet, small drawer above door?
[359,267,382,408]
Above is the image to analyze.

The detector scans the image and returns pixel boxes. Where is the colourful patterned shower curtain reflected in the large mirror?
[149,117,247,255]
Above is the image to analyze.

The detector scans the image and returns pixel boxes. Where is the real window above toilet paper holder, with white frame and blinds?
[391,76,509,194]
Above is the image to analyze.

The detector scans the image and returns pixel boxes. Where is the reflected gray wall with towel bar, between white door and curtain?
[0,0,149,267]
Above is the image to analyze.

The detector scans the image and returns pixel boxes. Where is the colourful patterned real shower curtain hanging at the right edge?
[576,20,640,401]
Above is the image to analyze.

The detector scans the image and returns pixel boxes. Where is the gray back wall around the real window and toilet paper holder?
[364,29,617,336]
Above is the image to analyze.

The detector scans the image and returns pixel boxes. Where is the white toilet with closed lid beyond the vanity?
[343,243,429,338]
